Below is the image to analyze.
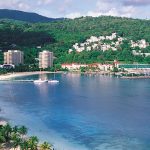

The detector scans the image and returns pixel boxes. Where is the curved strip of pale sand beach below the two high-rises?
[0,71,52,80]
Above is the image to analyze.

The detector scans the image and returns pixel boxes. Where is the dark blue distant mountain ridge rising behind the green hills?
[0,9,63,23]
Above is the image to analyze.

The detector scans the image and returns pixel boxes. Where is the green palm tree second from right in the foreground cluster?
[28,136,39,150]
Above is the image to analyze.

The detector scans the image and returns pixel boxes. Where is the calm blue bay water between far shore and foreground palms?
[0,74,150,150]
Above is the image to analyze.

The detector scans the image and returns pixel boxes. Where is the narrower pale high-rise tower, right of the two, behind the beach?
[39,50,54,69]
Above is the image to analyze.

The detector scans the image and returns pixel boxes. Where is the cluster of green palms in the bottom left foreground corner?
[0,124,52,150]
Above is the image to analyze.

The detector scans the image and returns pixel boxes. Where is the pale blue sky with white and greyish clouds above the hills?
[0,0,150,19]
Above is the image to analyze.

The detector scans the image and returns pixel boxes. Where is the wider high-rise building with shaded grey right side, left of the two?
[4,50,24,65]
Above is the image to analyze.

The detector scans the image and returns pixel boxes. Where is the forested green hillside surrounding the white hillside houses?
[0,16,150,68]
